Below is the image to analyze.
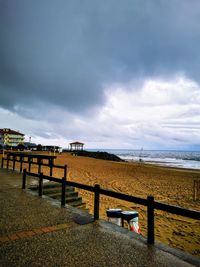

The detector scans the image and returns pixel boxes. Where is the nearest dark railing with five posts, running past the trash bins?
[22,169,200,244]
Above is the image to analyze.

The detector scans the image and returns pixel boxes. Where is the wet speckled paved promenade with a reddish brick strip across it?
[0,169,200,267]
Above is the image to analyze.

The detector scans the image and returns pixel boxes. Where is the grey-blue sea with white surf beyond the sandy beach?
[88,149,200,170]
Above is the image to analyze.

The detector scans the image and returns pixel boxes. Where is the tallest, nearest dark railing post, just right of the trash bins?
[147,196,154,244]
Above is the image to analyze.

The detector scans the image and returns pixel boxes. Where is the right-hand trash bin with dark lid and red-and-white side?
[121,211,140,234]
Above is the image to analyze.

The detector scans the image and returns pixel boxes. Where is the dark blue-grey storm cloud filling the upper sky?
[0,0,200,116]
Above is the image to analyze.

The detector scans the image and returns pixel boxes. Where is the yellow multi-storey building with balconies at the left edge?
[0,128,24,147]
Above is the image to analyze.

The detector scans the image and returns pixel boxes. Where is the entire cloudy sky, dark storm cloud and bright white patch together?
[0,0,200,150]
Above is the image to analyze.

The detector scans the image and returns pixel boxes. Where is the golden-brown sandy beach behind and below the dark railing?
[1,153,200,257]
